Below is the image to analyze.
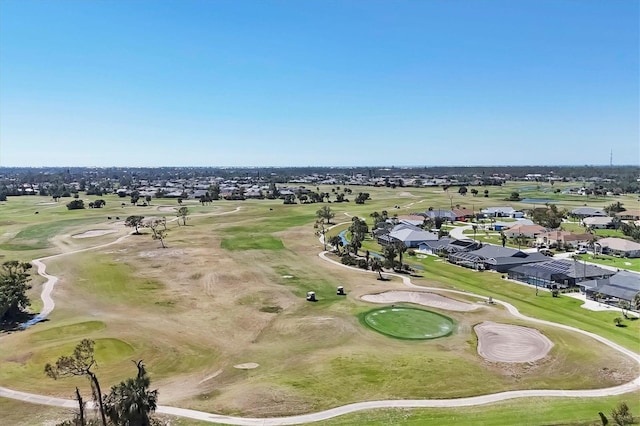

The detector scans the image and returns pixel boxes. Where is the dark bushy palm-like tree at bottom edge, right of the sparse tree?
[104,361,158,426]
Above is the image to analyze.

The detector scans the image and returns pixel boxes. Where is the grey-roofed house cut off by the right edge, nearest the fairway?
[580,271,640,304]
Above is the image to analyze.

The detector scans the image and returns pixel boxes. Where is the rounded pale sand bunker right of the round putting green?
[474,321,553,362]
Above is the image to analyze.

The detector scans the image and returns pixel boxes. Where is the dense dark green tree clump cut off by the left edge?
[0,260,31,322]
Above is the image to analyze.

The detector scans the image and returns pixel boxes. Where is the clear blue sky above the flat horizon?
[0,0,640,167]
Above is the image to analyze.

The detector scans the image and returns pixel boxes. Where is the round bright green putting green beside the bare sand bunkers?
[361,306,456,340]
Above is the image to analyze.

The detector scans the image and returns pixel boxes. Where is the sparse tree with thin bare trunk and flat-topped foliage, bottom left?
[44,339,107,426]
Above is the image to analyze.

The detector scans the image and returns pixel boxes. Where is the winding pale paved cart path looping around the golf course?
[0,212,640,426]
